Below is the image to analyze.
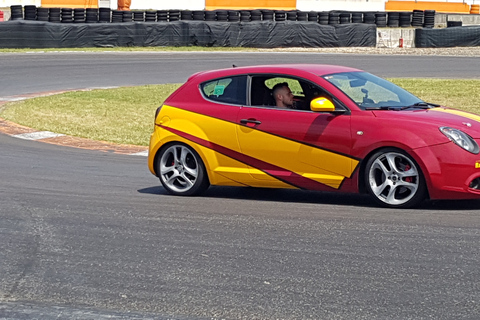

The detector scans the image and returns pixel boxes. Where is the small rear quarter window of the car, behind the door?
[200,76,247,105]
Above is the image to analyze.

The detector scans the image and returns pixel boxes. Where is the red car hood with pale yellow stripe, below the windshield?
[373,107,480,139]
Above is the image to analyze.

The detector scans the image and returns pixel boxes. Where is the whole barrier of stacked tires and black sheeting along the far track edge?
[0,6,480,48]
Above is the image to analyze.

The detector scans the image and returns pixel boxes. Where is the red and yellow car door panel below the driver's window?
[237,78,358,190]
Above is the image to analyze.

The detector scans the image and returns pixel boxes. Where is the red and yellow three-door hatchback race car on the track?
[148,64,480,208]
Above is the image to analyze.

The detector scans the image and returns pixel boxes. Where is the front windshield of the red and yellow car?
[324,72,424,110]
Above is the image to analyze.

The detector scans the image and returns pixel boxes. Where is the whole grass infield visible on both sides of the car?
[0,79,480,146]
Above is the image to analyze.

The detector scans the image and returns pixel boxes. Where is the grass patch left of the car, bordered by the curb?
[0,84,179,145]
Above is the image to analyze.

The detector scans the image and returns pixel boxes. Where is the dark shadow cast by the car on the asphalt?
[138,186,480,211]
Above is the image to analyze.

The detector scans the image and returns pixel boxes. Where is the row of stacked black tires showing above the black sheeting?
[3,5,435,28]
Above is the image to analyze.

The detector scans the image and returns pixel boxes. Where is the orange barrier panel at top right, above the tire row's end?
[385,0,470,13]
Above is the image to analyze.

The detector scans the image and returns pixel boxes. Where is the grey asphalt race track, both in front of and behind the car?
[0,53,480,320]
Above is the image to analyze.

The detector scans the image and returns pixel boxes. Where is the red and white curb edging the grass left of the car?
[0,88,148,156]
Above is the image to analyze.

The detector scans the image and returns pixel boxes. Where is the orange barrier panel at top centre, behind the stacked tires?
[205,0,297,10]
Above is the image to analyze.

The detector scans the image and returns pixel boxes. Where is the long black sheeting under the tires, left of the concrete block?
[0,20,377,48]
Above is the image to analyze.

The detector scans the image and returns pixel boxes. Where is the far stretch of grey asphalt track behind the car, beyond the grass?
[0,52,480,97]
